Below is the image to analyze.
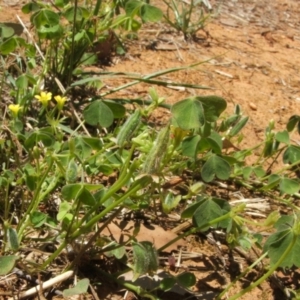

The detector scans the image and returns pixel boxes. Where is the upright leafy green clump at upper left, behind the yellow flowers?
[22,0,162,89]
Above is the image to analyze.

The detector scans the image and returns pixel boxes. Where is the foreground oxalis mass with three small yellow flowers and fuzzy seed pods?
[0,84,299,299]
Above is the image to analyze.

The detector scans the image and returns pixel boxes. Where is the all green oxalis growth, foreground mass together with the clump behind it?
[0,1,300,299]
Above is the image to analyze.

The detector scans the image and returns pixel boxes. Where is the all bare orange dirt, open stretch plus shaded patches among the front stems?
[0,0,300,299]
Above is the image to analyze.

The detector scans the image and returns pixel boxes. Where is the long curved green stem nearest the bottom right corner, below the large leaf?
[228,234,298,300]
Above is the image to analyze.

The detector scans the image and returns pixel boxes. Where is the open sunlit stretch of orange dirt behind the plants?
[110,0,300,152]
